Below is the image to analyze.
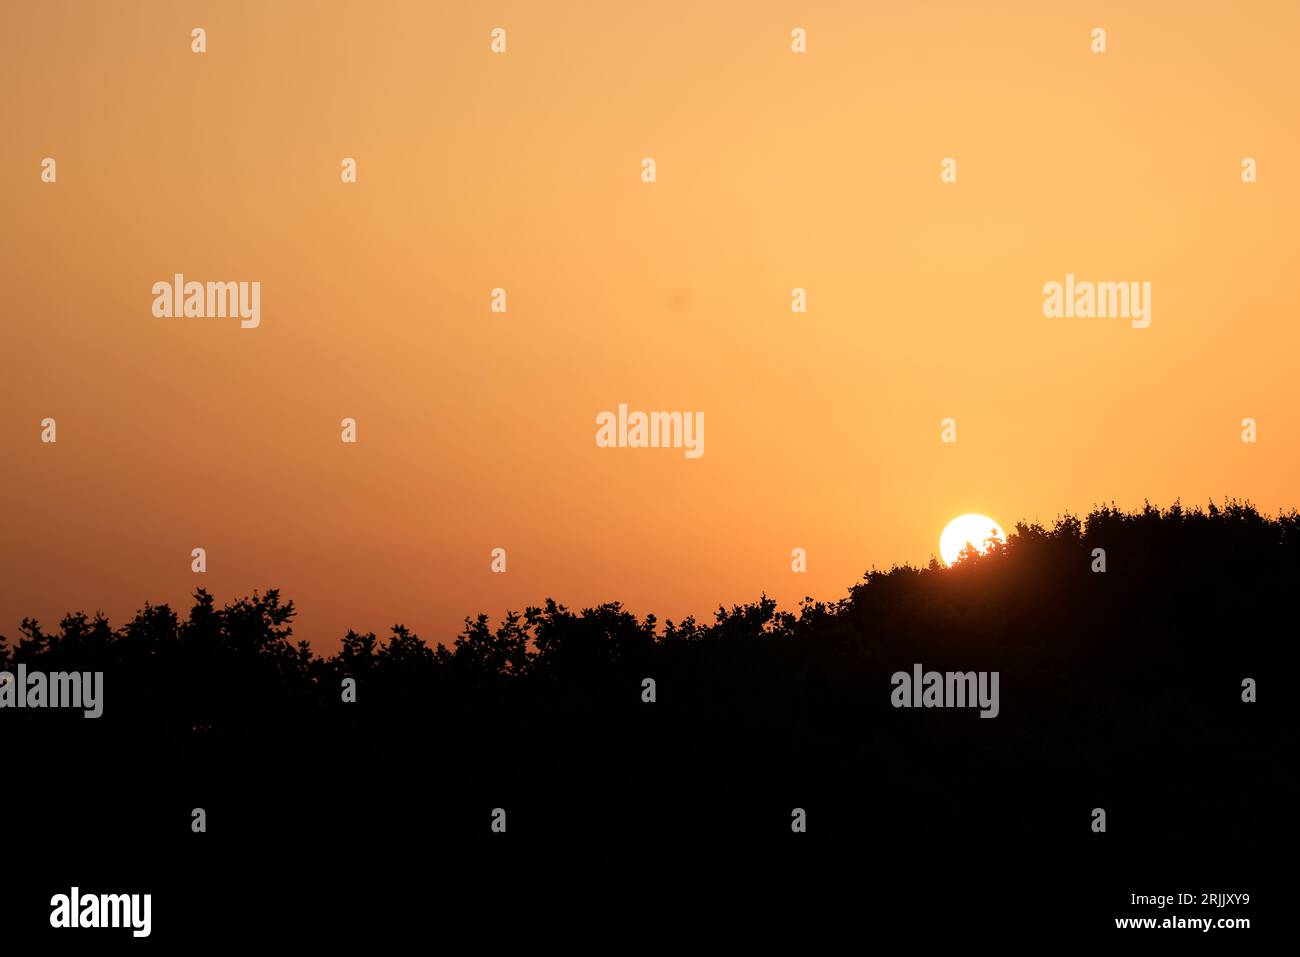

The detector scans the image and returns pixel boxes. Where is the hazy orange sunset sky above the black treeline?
[0,0,1300,651]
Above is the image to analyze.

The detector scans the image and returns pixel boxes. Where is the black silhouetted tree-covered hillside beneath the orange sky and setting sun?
[0,503,1279,941]
